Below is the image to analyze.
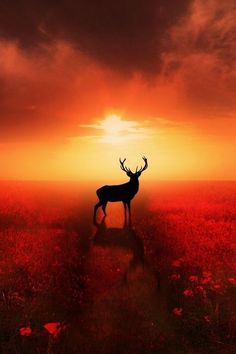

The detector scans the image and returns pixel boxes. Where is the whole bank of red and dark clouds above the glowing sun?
[0,0,236,141]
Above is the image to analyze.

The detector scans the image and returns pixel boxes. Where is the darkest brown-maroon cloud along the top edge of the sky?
[0,0,192,72]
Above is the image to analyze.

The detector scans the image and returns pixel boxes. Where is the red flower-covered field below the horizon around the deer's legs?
[0,182,236,354]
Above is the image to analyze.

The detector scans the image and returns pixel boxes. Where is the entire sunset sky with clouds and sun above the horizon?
[0,0,236,178]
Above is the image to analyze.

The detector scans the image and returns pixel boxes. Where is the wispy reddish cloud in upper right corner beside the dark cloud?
[163,0,236,113]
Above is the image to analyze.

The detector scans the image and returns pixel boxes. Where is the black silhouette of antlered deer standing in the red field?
[93,156,148,222]
